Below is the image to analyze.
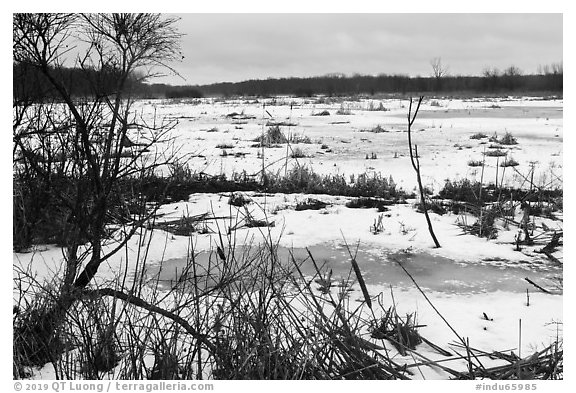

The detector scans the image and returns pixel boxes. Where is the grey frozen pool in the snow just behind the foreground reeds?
[148,244,562,294]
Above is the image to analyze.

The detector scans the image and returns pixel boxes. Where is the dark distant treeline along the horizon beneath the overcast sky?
[13,65,563,99]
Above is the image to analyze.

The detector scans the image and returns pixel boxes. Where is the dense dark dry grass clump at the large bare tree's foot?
[13,271,125,379]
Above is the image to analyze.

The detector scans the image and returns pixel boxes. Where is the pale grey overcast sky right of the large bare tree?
[154,13,563,84]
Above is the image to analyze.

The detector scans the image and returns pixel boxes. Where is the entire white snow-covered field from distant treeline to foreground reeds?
[13,97,563,379]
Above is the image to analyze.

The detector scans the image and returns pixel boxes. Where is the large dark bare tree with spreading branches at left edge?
[13,14,181,362]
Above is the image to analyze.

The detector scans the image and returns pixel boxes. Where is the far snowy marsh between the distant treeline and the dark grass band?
[132,98,563,191]
